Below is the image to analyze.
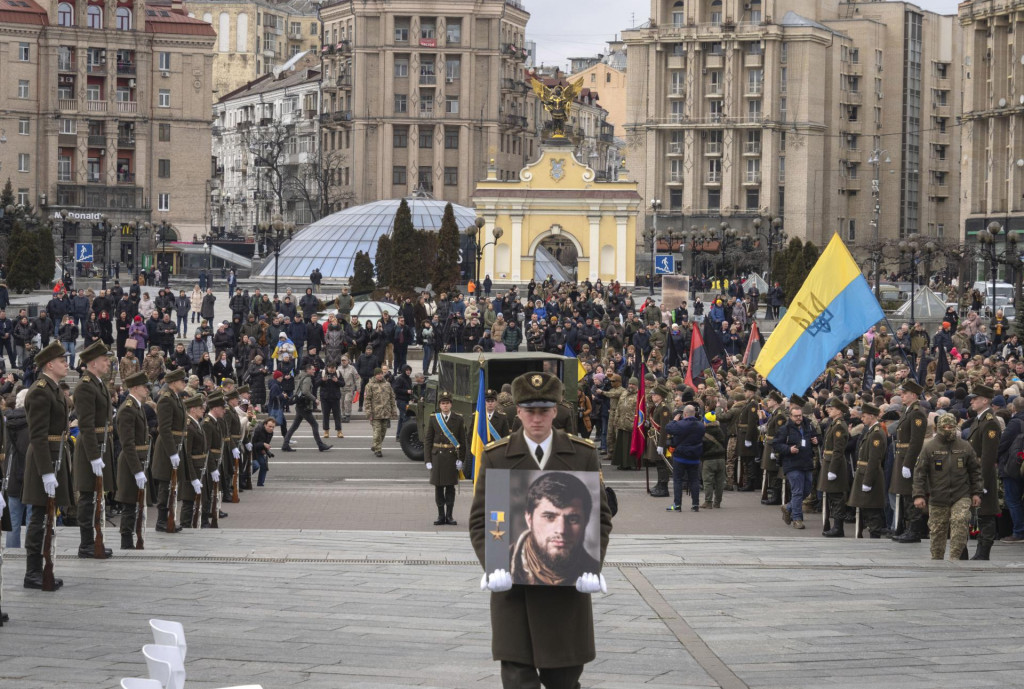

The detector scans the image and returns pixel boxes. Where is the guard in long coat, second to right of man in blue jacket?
[847,404,888,539]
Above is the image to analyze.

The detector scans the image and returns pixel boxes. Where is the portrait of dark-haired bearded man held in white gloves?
[484,469,602,587]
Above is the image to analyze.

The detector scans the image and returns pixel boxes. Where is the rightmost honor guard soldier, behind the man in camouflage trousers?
[967,385,1001,560]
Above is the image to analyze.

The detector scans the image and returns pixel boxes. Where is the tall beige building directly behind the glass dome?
[321,0,539,205]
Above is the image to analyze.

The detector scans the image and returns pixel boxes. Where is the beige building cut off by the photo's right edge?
[959,1,1024,279]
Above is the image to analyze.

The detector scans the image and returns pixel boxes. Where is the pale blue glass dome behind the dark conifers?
[260,197,476,277]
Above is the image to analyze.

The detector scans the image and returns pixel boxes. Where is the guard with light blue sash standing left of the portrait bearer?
[423,390,466,526]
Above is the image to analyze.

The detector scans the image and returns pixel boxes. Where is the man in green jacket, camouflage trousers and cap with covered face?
[912,415,983,560]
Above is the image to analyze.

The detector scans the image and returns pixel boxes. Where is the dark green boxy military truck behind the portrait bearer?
[398,352,579,462]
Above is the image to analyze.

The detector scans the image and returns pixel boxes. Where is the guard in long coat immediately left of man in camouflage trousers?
[889,380,928,543]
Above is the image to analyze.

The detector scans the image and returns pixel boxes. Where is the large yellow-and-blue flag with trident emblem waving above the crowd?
[754,234,885,396]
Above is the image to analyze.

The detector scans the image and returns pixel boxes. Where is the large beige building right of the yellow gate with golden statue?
[624,0,961,269]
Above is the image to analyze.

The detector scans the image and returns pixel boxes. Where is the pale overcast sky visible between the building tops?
[522,0,957,69]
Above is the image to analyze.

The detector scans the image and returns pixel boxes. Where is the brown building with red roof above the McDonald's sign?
[0,0,214,263]
